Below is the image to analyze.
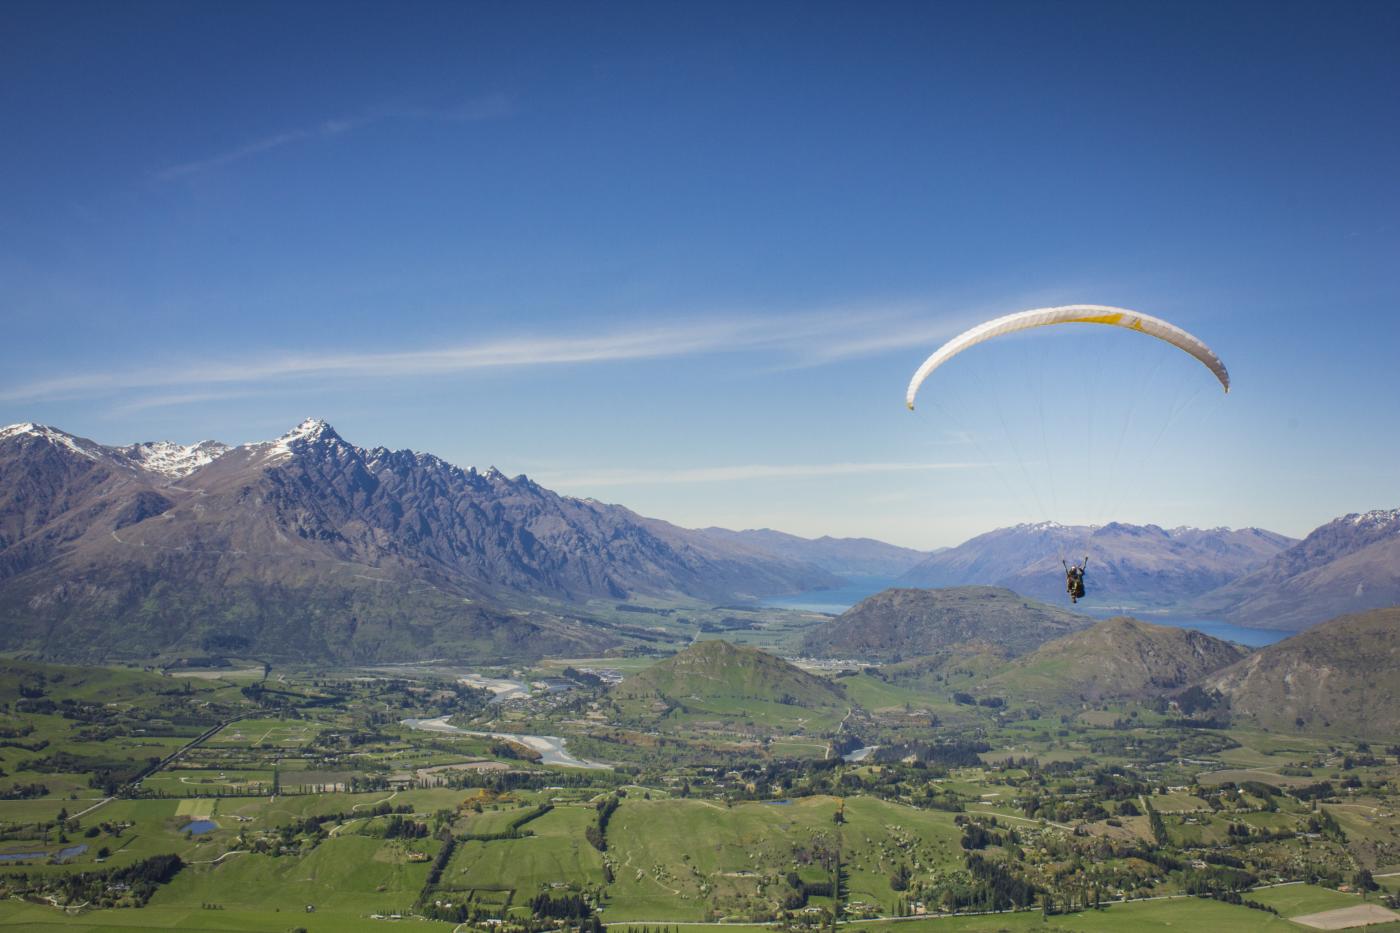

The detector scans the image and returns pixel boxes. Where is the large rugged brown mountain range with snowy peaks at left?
[0,420,836,660]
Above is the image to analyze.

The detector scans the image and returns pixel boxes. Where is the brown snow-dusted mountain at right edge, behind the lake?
[1193,509,1400,630]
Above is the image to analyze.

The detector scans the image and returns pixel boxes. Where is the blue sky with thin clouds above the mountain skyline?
[0,3,1400,546]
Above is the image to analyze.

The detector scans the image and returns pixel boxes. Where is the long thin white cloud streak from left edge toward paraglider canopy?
[0,307,951,403]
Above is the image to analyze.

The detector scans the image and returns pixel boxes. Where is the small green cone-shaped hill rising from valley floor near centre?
[609,640,848,716]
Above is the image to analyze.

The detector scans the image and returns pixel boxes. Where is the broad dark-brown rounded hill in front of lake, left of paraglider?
[802,587,1092,661]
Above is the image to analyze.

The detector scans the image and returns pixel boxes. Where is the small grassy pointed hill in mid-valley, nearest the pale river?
[609,640,850,727]
